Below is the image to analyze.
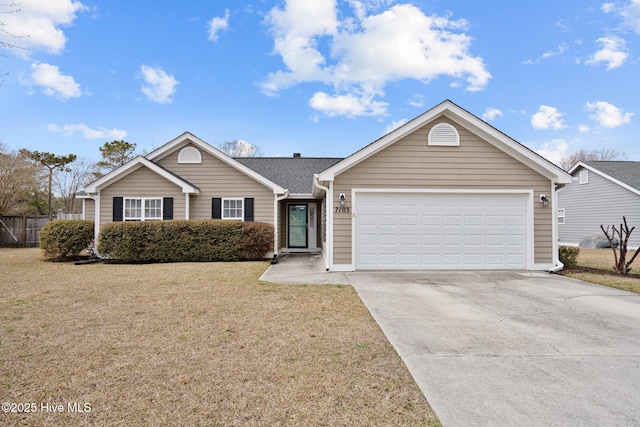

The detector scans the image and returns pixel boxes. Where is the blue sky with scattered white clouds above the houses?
[0,0,640,166]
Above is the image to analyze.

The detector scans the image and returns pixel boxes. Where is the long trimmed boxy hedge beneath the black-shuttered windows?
[98,220,273,263]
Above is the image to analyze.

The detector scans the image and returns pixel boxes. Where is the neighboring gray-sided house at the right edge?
[557,161,640,247]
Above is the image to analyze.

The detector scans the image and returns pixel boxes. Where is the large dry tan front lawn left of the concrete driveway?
[0,249,438,426]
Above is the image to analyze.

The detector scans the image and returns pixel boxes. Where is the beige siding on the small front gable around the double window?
[100,166,186,225]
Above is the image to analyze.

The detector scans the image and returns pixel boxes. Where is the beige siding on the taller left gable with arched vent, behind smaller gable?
[157,144,274,224]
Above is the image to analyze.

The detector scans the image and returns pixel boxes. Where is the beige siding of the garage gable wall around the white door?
[332,118,555,264]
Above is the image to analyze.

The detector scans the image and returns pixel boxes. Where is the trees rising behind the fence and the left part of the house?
[0,140,261,217]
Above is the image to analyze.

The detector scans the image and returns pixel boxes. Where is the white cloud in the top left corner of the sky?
[2,0,86,57]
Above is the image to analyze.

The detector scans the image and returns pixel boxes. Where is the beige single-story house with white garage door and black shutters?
[83,100,571,271]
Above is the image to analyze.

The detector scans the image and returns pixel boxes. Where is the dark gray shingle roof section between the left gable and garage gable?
[235,157,342,194]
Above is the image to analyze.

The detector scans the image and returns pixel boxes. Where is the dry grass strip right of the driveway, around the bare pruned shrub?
[562,248,640,293]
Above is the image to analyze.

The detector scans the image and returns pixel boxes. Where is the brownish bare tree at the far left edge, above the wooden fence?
[0,143,39,215]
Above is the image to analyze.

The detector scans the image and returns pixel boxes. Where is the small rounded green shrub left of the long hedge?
[40,219,94,259]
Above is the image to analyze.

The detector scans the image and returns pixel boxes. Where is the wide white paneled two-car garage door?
[355,192,527,270]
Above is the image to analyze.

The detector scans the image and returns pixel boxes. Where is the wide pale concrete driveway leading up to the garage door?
[346,272,640,427]
